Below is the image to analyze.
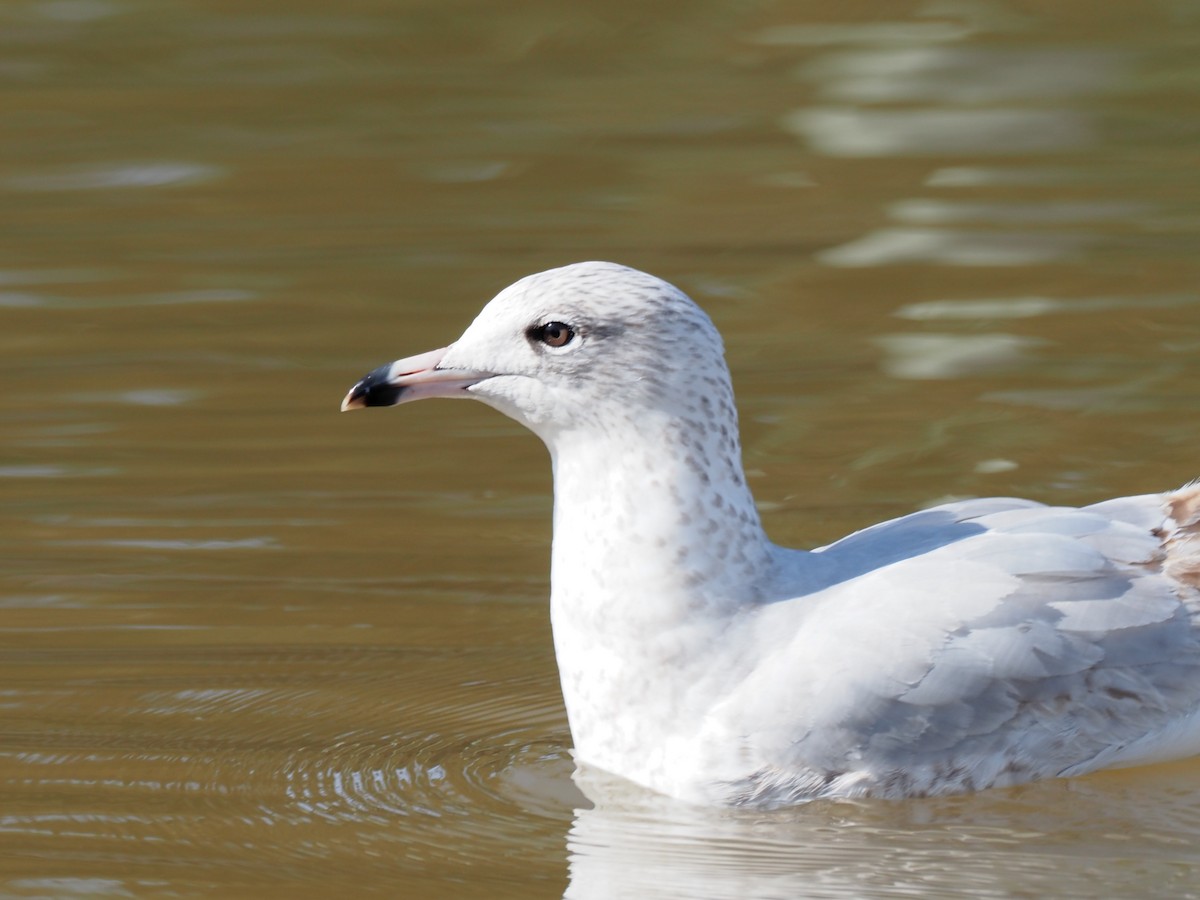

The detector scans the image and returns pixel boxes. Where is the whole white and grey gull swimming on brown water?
[342,263,1200,806]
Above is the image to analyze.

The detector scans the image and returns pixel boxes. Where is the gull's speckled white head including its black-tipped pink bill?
[342,263,732,440]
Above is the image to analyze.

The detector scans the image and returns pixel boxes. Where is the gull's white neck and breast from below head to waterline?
[551,405,776,774]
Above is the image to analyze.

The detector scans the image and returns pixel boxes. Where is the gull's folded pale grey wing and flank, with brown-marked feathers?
[724,487,1200,798]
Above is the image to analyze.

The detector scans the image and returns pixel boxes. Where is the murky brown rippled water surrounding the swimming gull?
[0,0,1200,898]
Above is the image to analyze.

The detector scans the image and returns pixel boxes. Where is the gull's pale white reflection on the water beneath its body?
[565,766,1200,900]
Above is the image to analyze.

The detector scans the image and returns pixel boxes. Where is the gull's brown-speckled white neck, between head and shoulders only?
[552,416,772,620]
